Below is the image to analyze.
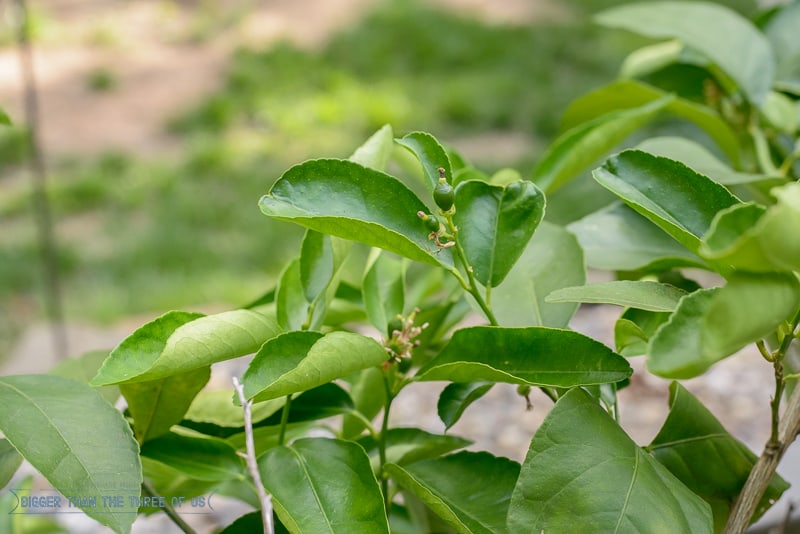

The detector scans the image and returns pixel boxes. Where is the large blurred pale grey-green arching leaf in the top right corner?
[595,2,775,105]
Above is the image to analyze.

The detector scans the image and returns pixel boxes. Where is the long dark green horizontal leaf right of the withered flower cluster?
[414,326,631,387]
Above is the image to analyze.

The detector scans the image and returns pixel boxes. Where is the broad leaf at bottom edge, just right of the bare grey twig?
[258,438,389,534]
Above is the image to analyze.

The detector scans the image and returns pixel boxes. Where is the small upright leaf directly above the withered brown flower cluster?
[362,252,405,337]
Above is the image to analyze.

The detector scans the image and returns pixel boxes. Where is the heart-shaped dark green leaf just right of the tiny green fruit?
[453,181,545,287]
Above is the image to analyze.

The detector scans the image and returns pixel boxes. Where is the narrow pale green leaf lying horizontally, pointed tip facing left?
[545,280,686,311]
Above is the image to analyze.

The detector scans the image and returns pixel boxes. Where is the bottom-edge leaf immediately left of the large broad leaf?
[386,451,527,534]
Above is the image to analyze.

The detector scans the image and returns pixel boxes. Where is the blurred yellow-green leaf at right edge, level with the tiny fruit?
[699,183,800,272]
